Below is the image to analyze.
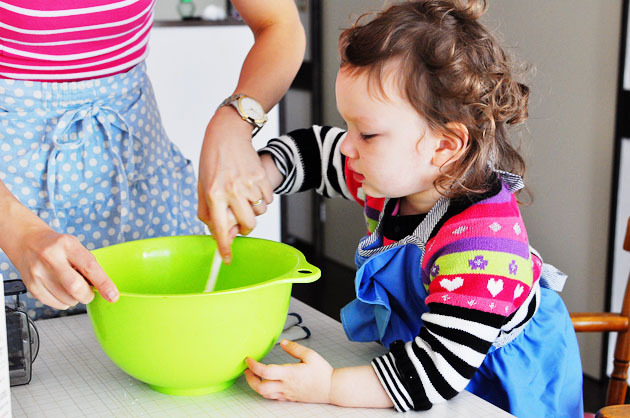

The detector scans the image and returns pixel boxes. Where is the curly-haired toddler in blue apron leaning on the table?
[246,0,583,418]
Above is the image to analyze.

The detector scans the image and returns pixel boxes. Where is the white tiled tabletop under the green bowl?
[11,299,512,418]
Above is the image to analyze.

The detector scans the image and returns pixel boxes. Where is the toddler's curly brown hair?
[339,0,529,197]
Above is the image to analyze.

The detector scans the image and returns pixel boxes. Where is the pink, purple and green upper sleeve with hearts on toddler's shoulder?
[423,183,533,315]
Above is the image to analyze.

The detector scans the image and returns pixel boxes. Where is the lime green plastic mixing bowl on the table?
[87,236,320,395]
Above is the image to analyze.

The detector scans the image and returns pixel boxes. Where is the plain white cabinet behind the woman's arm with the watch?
[147,21,280,241]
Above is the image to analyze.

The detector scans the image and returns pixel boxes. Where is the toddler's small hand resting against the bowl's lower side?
[245,340,334,403]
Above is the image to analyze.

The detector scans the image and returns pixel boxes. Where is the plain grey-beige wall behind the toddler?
[323,0,621,376]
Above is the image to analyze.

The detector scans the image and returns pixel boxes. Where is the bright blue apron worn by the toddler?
[341,173,583,418]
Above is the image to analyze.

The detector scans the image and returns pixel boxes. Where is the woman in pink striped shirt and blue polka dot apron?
[0,0,304,317]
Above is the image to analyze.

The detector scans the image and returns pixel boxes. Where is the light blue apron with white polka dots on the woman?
[0,64,206,319]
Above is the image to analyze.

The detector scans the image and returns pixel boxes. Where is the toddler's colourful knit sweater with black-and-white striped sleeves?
[260,126,542,412]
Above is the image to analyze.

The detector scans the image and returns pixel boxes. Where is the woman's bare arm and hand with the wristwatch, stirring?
[198,0,305,263]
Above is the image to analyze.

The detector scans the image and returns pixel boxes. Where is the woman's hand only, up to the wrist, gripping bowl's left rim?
[12,225,119,309]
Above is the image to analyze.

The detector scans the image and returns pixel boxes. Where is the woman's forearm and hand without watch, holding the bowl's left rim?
[0,181,118,309]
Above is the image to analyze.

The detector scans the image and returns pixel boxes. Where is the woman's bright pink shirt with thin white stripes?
[0,0,156,81]
